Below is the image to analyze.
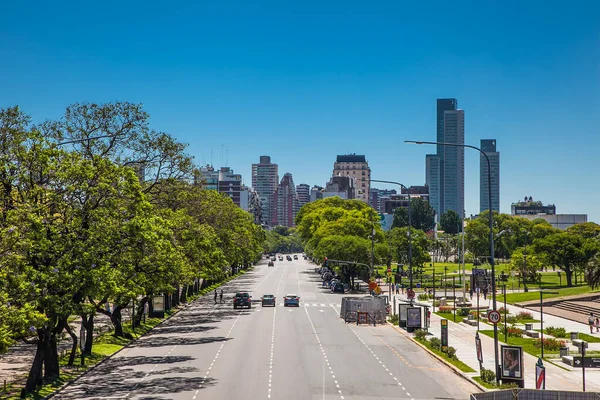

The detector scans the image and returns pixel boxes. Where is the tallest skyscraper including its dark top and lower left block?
[425,98,465,221]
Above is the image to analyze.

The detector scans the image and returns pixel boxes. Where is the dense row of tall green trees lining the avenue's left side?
[0,102,265,391]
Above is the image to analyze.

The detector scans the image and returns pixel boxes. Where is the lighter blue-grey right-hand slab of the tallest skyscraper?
[440,110,465,218]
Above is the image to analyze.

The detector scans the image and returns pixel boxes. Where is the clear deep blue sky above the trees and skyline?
[0,0,600,222]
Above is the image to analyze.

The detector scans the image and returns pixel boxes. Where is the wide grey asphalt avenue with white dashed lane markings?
[55,259,478,400]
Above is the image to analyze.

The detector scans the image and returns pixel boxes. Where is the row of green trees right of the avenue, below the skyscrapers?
[296,197,600,287]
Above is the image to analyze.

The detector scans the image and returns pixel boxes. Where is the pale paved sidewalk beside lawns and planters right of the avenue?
[383,288,600,392]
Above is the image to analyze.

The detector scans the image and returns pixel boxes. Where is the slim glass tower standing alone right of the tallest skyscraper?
[479,139,500,212]
